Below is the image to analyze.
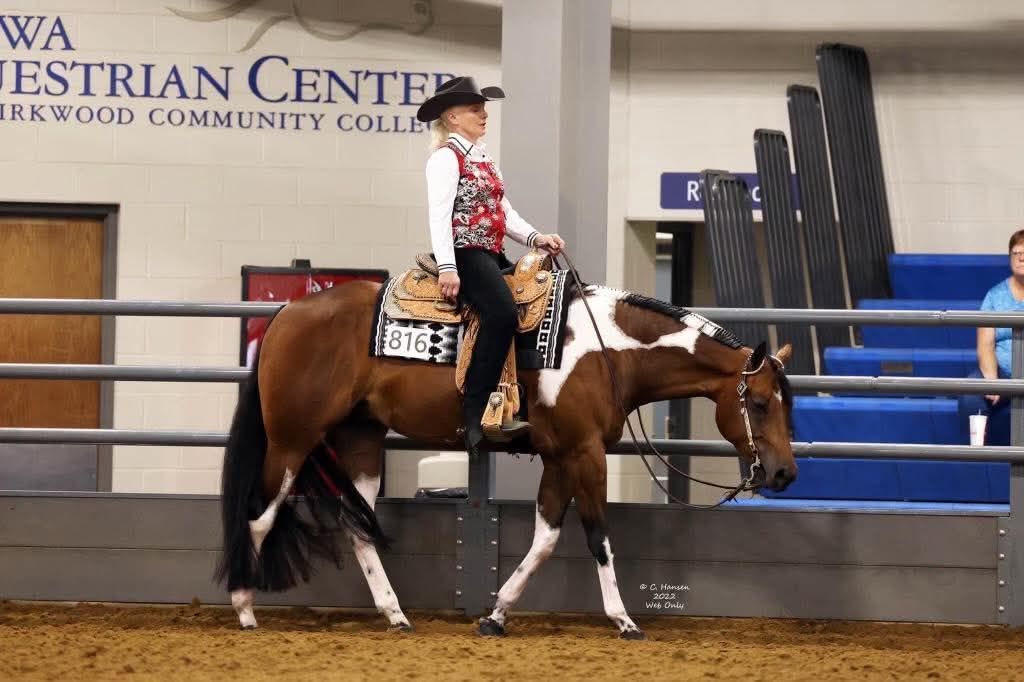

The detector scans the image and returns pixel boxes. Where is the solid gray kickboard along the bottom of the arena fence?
[0,495,1000,623]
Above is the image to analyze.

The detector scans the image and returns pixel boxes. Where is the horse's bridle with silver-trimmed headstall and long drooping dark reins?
[553,251,781,509]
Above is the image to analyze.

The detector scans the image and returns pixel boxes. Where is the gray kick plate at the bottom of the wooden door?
[0,444,97,491]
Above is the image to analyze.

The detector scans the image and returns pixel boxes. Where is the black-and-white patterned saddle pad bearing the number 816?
[370,270,568,370]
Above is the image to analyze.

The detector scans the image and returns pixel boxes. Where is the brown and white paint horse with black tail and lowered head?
[218,282,797,639]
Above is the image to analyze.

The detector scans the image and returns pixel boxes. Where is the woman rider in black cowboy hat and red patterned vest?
[416,77,565,455]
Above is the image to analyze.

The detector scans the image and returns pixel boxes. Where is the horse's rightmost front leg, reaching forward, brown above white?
[574,440,645,639]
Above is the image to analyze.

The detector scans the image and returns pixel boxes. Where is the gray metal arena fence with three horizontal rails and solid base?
[0,299,1024,625]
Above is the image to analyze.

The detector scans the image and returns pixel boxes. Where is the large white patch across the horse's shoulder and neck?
[538,287,710,407]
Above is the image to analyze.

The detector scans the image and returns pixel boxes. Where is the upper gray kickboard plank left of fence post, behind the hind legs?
[0,496,455,554]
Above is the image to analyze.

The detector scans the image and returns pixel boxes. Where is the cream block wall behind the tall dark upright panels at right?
[609,31,1024,258]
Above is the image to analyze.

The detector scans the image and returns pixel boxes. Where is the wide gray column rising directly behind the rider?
[501,0,611,283]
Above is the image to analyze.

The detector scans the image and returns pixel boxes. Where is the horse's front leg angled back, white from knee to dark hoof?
[479,460,572,637]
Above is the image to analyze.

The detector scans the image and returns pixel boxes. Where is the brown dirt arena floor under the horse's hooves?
[0,602,1024,682]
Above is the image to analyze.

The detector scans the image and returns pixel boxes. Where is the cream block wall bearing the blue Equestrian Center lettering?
[0,0,501,494]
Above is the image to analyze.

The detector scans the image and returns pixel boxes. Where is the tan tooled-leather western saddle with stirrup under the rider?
[383,251,554,440]
